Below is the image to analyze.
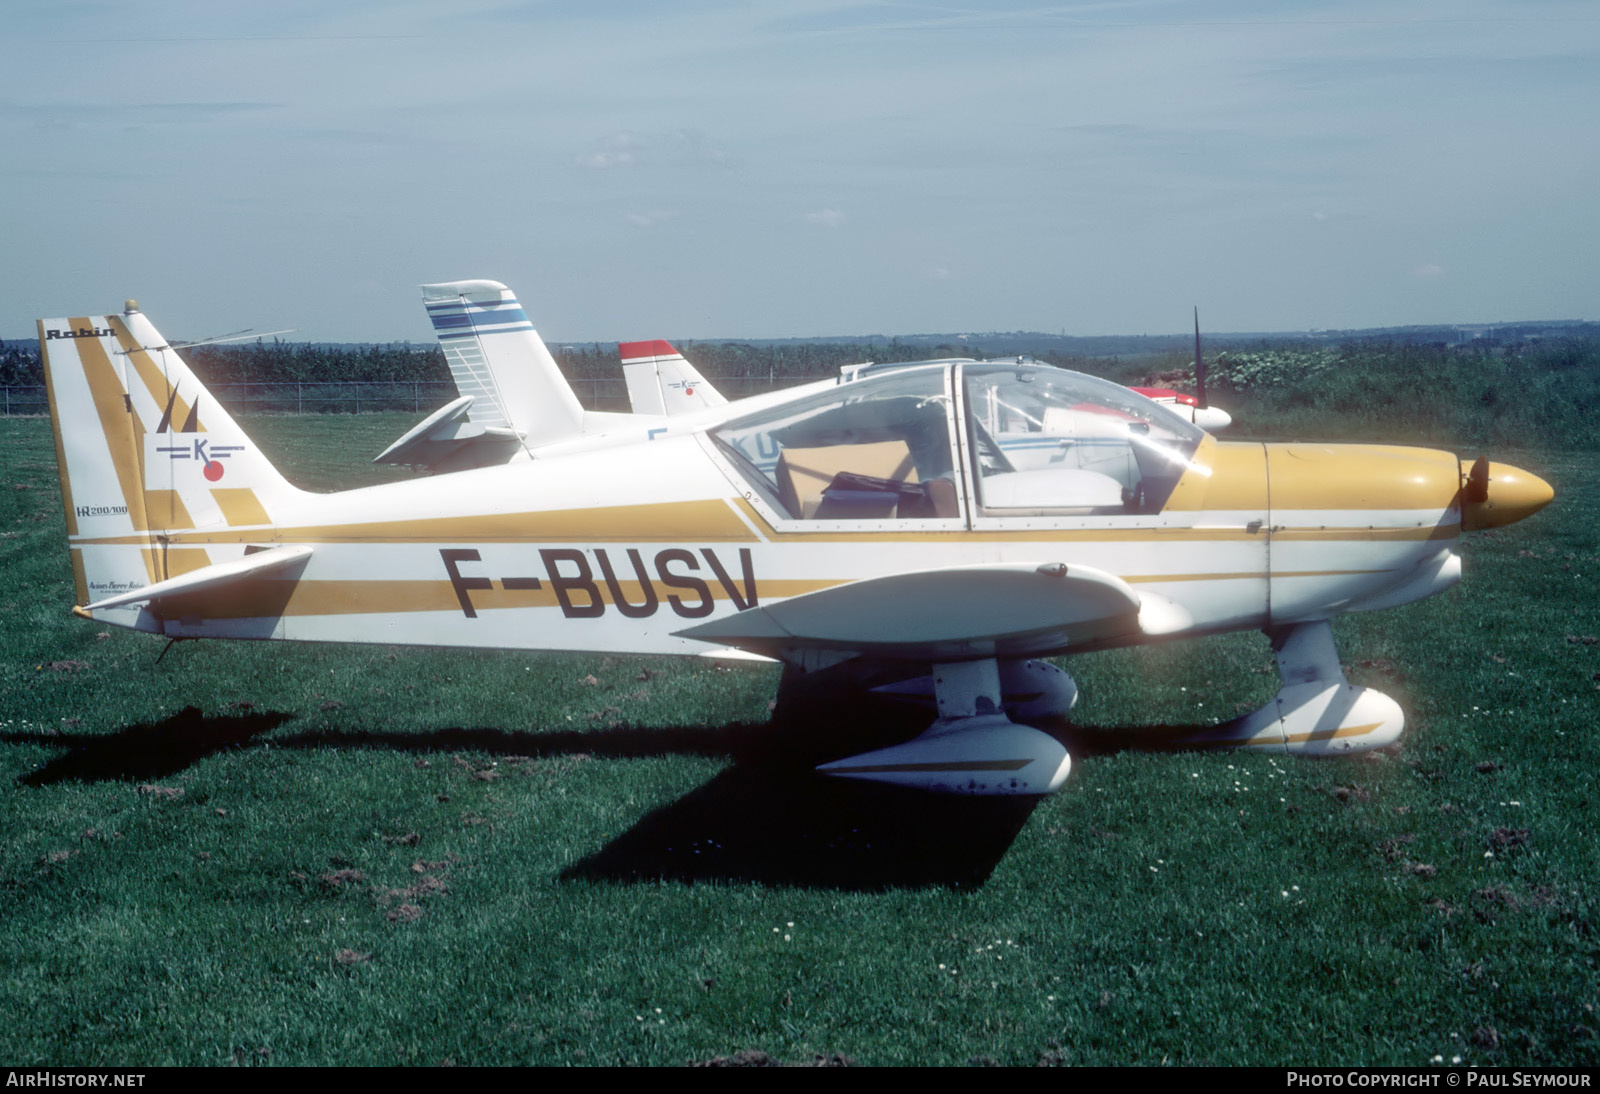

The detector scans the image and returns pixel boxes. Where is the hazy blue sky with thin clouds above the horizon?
[0,0,1600,341]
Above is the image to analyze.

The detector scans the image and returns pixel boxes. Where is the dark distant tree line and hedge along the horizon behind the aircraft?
[0,333,1600,448]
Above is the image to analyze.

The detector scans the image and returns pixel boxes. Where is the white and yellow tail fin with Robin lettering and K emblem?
[38,301,299,630]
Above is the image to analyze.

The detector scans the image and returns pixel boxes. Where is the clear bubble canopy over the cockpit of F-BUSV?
[712,363,1205,521]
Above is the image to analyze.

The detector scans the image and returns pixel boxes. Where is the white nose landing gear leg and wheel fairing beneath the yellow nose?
[1184,619,1405,757]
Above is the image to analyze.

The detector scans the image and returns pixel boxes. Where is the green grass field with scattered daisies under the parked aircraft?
[0,416,1600,1065]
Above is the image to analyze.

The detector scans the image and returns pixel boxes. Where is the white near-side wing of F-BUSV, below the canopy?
[677,561,1192,662]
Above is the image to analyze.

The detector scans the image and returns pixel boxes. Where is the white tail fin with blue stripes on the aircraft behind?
[422,281,584,448]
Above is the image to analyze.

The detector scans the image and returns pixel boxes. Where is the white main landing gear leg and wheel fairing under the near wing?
[818,657,1072,795]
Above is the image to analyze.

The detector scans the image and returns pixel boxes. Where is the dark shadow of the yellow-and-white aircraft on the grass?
[0,707,1235,891]
